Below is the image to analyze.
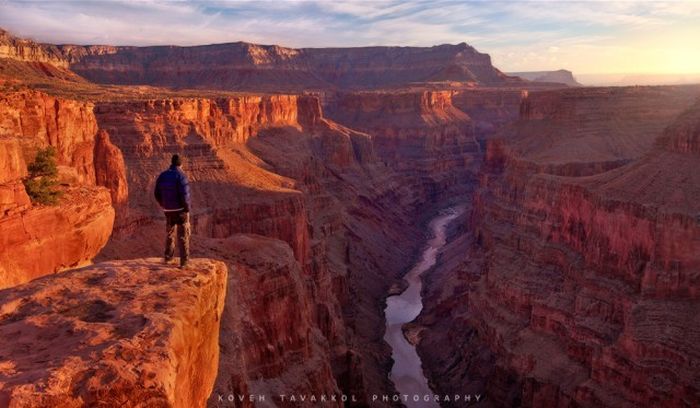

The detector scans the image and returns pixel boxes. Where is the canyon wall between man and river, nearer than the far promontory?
[85,95,434,402]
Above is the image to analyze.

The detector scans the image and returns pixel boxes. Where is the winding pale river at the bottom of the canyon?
[384,208,464,407]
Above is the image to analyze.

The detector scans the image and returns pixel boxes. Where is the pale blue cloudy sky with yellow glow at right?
[0,0,700,74]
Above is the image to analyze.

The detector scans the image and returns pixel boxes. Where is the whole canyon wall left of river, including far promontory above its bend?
[86,84,521,404]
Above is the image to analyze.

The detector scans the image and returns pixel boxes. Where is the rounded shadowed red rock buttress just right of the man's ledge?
[208,235,342,407]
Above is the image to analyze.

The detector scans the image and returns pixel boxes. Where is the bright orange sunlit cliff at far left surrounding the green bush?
[0,91,127,287]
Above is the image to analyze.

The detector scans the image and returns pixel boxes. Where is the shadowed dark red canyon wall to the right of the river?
[419,87,700,407]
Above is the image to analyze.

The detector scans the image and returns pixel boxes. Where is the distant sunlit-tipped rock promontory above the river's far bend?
[326,91,480,210]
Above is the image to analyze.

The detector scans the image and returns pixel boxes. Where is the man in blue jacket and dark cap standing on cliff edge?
[155,154,191,268]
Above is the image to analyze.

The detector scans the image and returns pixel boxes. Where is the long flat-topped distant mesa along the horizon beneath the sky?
[0,30,522,91]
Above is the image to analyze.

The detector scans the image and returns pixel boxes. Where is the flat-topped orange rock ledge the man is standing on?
[0,259,227,408]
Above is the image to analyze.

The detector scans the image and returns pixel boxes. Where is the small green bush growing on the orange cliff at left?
[24,146,61,205]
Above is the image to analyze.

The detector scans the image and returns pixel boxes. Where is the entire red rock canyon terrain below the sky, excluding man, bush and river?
[0,27,700,407]
